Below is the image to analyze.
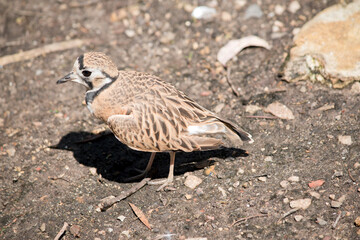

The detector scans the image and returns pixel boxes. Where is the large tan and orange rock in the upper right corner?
[283,1,360,88]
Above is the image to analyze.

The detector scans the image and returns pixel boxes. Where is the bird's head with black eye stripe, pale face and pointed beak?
[56,52,119,90]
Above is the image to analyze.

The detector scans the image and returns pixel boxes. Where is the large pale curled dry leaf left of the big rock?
[217,36,271,66]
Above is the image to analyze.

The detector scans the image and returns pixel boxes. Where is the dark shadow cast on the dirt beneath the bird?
[51,132,248,182]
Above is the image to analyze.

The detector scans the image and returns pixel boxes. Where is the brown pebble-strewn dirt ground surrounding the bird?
[0,0,360,239]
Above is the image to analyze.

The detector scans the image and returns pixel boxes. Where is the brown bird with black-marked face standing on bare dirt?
[56,52,254,191]
